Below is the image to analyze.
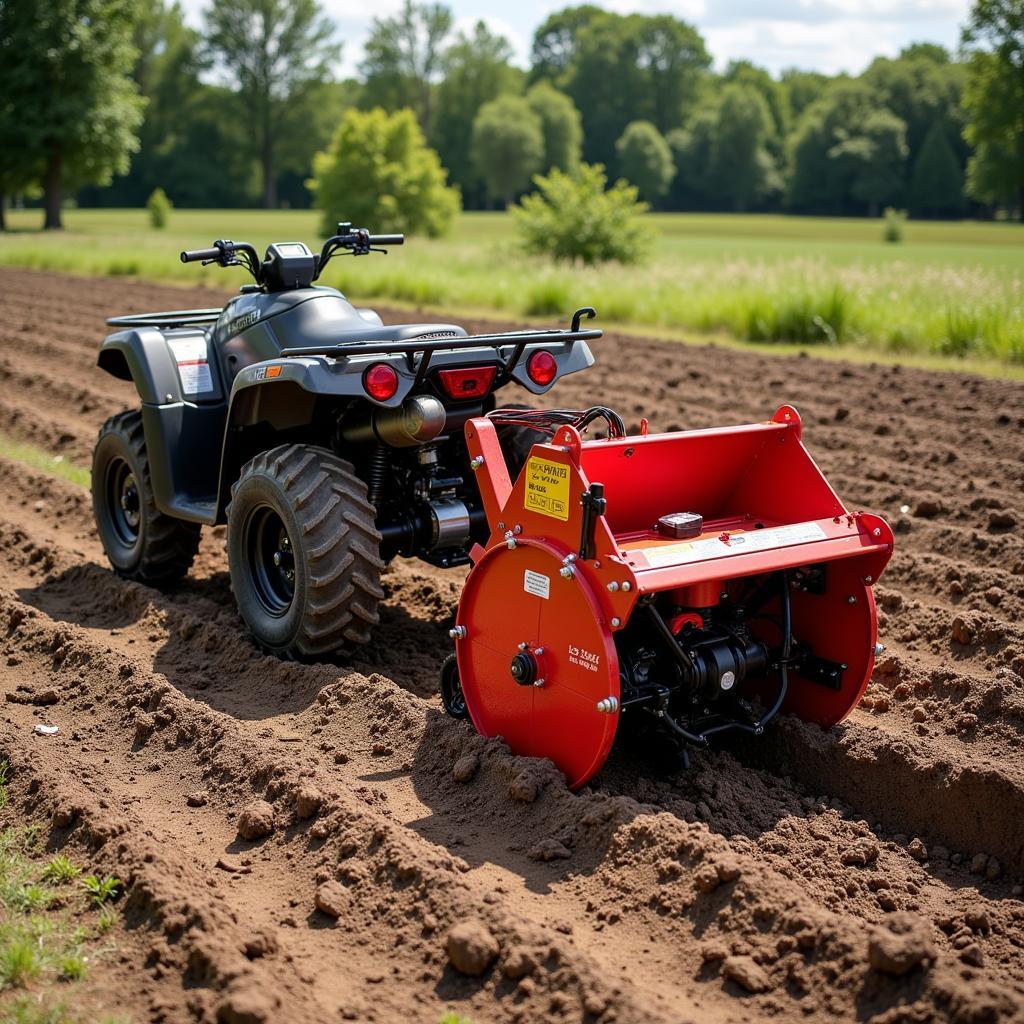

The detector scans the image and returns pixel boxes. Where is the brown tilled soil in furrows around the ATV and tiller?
[0,270,1024,1024]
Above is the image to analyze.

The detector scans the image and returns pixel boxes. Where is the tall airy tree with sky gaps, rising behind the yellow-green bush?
[359,0,452,138]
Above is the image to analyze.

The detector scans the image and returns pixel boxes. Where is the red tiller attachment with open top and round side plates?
[442,406,893,787]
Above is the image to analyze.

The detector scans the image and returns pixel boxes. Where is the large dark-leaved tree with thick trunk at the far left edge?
[0,0,143,228]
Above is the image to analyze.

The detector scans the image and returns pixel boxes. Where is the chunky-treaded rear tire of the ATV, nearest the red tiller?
[227,444,384,658]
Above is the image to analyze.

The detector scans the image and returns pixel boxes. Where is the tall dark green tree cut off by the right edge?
[963,0,1024,220]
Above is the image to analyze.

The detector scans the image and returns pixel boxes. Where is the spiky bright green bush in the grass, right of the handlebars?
[512,164,651,264]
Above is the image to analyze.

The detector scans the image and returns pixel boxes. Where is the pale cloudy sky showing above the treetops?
[182,0,971,78]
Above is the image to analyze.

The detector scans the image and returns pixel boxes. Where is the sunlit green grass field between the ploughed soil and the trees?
[0,210,1024,369]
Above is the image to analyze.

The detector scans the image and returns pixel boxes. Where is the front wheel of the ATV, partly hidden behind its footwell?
[92,412,200,586]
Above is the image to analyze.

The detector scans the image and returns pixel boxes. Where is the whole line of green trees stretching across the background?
[0,0,1024,226]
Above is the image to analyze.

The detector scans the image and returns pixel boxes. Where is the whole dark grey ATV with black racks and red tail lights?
[92,223,601,658]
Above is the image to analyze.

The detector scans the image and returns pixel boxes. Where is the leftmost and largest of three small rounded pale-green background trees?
[473,96,544,203]
